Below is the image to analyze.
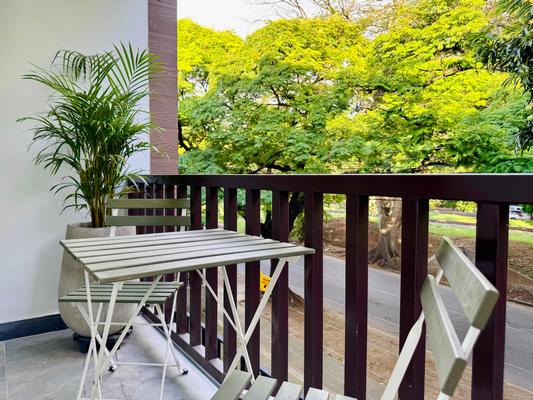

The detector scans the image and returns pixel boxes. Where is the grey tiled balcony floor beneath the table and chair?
[0,318,216,400]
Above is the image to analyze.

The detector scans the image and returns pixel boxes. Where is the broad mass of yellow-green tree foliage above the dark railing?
[178,0,529,180]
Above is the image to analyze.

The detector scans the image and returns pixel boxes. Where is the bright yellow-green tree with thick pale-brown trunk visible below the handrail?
[336,0,516,264]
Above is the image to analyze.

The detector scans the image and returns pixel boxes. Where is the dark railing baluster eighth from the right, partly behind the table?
[205,187,218,360]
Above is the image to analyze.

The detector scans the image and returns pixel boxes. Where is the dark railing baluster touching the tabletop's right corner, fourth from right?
[304,193,324,393]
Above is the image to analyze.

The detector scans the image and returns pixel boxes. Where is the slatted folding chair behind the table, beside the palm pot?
[59,199,190,400]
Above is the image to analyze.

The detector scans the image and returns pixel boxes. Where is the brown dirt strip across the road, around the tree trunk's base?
[324,219,533,305]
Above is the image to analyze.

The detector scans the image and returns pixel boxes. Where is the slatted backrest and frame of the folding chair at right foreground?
[381,237,499,400]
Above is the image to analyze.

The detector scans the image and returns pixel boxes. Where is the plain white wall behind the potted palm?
[0,0,149,323]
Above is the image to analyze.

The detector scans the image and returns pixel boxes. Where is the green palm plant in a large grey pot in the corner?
[21,44,159,336]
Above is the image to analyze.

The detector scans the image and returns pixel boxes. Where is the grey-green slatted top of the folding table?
[60,229,314,283]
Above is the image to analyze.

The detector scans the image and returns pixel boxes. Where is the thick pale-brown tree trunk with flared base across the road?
[368,198,402,269]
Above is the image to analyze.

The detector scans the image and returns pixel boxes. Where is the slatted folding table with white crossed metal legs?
[61,229,314,399]
